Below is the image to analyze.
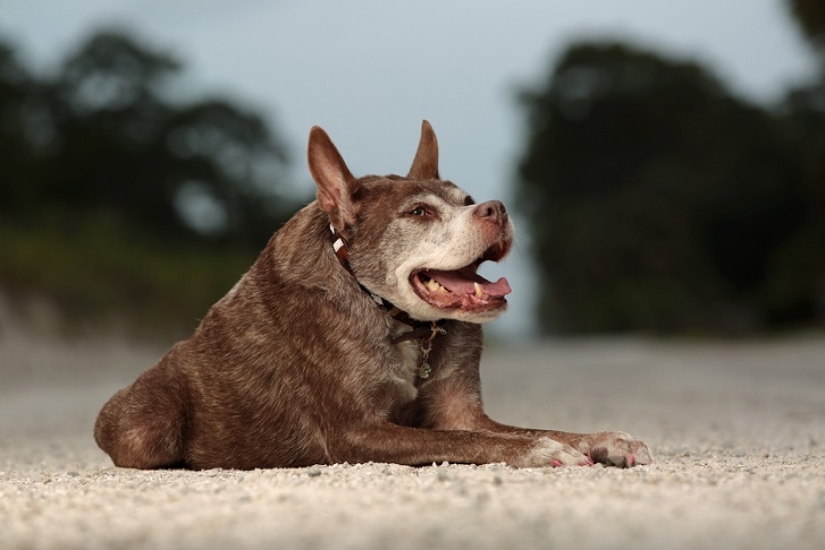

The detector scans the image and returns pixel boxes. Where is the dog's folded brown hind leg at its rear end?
[95,363,187,469]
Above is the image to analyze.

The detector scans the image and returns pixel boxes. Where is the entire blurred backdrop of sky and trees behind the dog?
[0,0,825,340]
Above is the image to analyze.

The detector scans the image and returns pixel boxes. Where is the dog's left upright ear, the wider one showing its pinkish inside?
[307,126,356,234]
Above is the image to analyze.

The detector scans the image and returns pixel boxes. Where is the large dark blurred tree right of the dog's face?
[518,44,823,332]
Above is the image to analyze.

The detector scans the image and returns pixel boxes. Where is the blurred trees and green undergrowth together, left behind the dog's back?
[0,31,298,332]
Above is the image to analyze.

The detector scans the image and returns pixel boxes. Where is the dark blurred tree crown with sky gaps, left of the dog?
[6,28,294,249]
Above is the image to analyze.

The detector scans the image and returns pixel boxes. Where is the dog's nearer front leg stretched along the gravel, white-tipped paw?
[327,420,589,468]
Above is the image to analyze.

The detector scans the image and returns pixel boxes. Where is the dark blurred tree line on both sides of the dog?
[0,0,825,334]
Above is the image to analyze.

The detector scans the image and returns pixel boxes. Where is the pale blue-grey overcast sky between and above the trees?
[0,0,813,336]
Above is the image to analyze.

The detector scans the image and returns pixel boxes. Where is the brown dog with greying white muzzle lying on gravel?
[94,121,652,470]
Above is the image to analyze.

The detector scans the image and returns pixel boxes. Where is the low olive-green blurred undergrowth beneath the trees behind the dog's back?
[0,218,255,339]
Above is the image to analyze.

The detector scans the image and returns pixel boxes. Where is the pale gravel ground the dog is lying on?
[0,331,825,550]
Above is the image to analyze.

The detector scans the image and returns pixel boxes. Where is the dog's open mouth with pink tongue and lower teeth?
[410,259,511,311]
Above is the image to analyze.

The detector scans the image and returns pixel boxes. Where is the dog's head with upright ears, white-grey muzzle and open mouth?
[309,121,513,323]
